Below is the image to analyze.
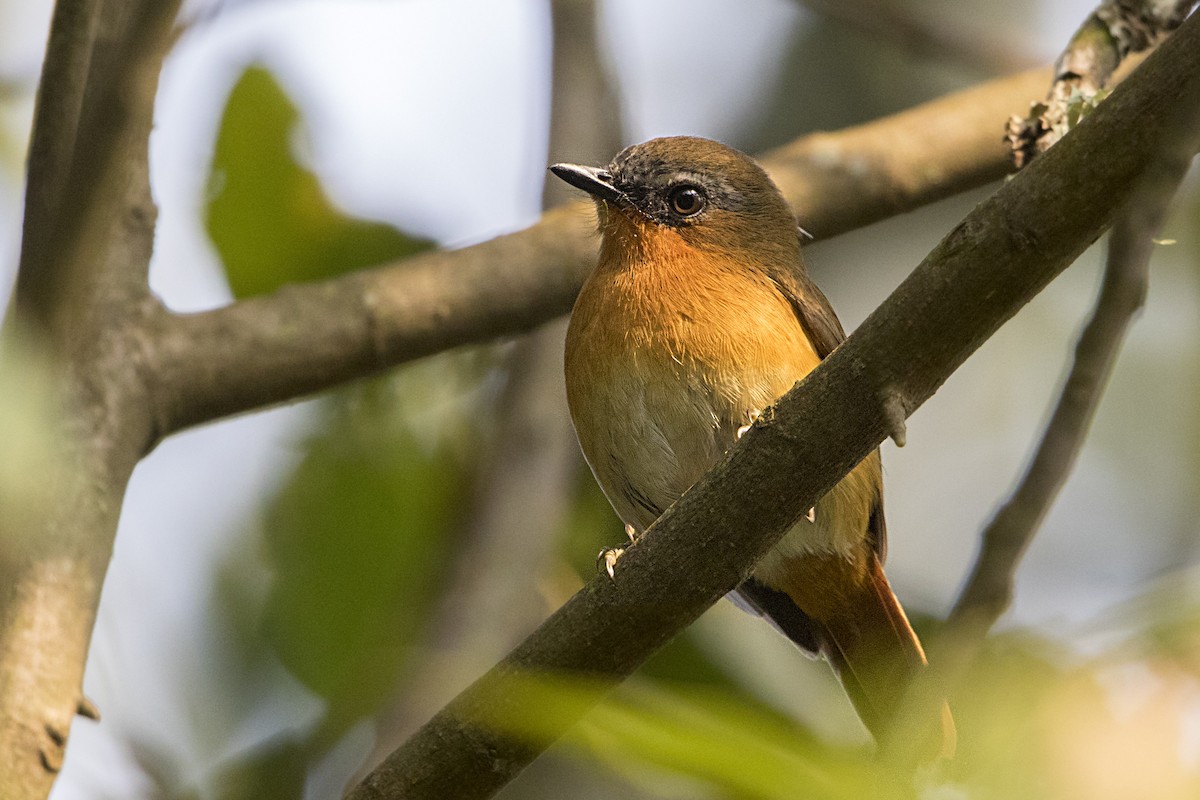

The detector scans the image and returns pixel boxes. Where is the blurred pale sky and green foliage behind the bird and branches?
[0,0,1200,800]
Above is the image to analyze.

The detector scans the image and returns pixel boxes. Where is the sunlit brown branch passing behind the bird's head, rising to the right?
[152,71,1048,434]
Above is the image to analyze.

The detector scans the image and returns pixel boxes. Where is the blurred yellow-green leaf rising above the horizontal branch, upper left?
[206,67,428,297]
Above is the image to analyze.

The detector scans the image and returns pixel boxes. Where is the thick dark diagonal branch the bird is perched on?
[352,14,1200,800]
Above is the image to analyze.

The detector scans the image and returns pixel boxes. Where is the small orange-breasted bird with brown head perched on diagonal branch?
[550,136,955,756]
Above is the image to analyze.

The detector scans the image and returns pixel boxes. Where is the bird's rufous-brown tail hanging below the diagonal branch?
[815,553,956,757]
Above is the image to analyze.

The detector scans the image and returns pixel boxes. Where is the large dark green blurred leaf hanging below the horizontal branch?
[265,380,466,718]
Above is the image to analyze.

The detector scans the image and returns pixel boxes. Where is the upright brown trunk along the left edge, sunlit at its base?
[0,0,178,799]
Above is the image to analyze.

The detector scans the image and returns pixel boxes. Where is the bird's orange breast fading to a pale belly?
[566,215,820,530]
